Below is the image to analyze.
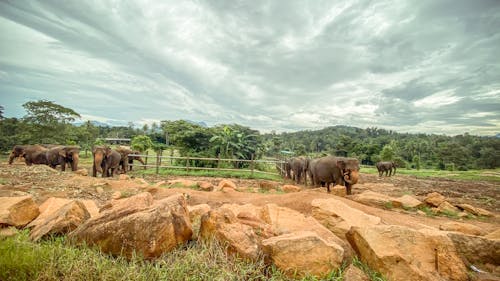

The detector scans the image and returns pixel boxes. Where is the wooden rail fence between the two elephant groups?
[129,152,285,176]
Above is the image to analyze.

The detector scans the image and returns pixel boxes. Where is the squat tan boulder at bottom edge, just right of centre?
[262,231,344,278]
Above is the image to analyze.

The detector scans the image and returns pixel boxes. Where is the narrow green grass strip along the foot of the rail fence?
[130,168,282,181]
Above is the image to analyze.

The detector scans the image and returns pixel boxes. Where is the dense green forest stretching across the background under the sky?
[0,100,500,170]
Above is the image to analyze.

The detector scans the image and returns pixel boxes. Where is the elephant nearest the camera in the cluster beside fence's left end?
[92,146,126,178]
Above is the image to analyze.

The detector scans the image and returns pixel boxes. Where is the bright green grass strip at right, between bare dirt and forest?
[361,166,500,182]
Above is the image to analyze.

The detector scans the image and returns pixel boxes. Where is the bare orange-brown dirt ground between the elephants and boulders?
[0,162,500,232]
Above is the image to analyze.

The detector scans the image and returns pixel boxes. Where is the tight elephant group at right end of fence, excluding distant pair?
[285,156,359,194]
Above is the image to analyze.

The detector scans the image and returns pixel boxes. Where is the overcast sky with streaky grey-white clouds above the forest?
[0,0,500,135]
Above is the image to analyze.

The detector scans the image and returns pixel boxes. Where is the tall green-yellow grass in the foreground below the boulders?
[0,230,385,281]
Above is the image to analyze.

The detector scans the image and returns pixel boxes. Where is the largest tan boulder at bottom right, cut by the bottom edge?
[347,225,468,281]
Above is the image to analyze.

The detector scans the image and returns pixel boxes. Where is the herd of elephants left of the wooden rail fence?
[9,144,144,177]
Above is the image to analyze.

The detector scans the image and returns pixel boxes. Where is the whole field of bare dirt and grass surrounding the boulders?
[0,158,500,280]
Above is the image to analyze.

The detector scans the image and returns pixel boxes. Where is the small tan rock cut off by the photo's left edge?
[0,195,40,227]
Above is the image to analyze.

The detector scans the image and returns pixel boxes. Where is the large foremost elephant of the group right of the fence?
[309,156,359,195]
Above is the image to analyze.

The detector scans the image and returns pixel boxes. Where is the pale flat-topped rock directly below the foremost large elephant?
[311,199,380,239]
